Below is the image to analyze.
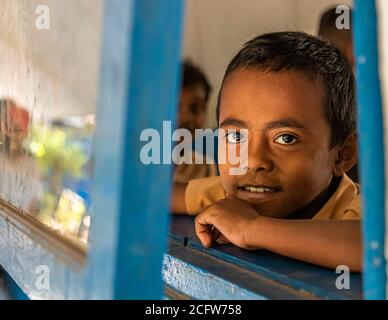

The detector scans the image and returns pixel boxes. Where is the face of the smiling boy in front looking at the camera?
[219,69,336,218]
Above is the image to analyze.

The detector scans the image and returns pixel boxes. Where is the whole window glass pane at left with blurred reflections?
[0,0,103,242]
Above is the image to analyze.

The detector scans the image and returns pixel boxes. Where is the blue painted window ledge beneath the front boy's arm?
[162,216,362,300]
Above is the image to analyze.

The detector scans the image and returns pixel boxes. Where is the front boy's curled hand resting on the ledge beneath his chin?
[195,198,260,250]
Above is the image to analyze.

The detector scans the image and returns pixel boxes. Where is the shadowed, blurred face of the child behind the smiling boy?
[178,85,206,134]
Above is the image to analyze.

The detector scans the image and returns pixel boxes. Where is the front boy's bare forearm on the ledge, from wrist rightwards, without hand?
[246,217,362,272]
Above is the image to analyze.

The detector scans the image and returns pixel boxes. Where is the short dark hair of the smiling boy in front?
[217,32,357,146]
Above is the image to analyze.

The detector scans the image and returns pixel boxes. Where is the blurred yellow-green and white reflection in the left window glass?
[27,117,94,241]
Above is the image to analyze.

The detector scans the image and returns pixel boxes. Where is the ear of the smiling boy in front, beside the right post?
[332,132,358,177]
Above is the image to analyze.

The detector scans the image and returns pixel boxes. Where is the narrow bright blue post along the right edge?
[354,0,387,299]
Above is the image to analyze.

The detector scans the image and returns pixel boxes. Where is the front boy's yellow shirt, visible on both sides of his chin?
[185,174,361,220]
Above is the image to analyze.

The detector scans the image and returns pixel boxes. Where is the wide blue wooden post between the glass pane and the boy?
[87,0,183,299]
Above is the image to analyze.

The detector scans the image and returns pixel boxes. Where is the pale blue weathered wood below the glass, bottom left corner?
[0,209,85,299]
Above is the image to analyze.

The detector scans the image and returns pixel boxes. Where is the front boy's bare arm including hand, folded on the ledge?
[195,198,361,271]
